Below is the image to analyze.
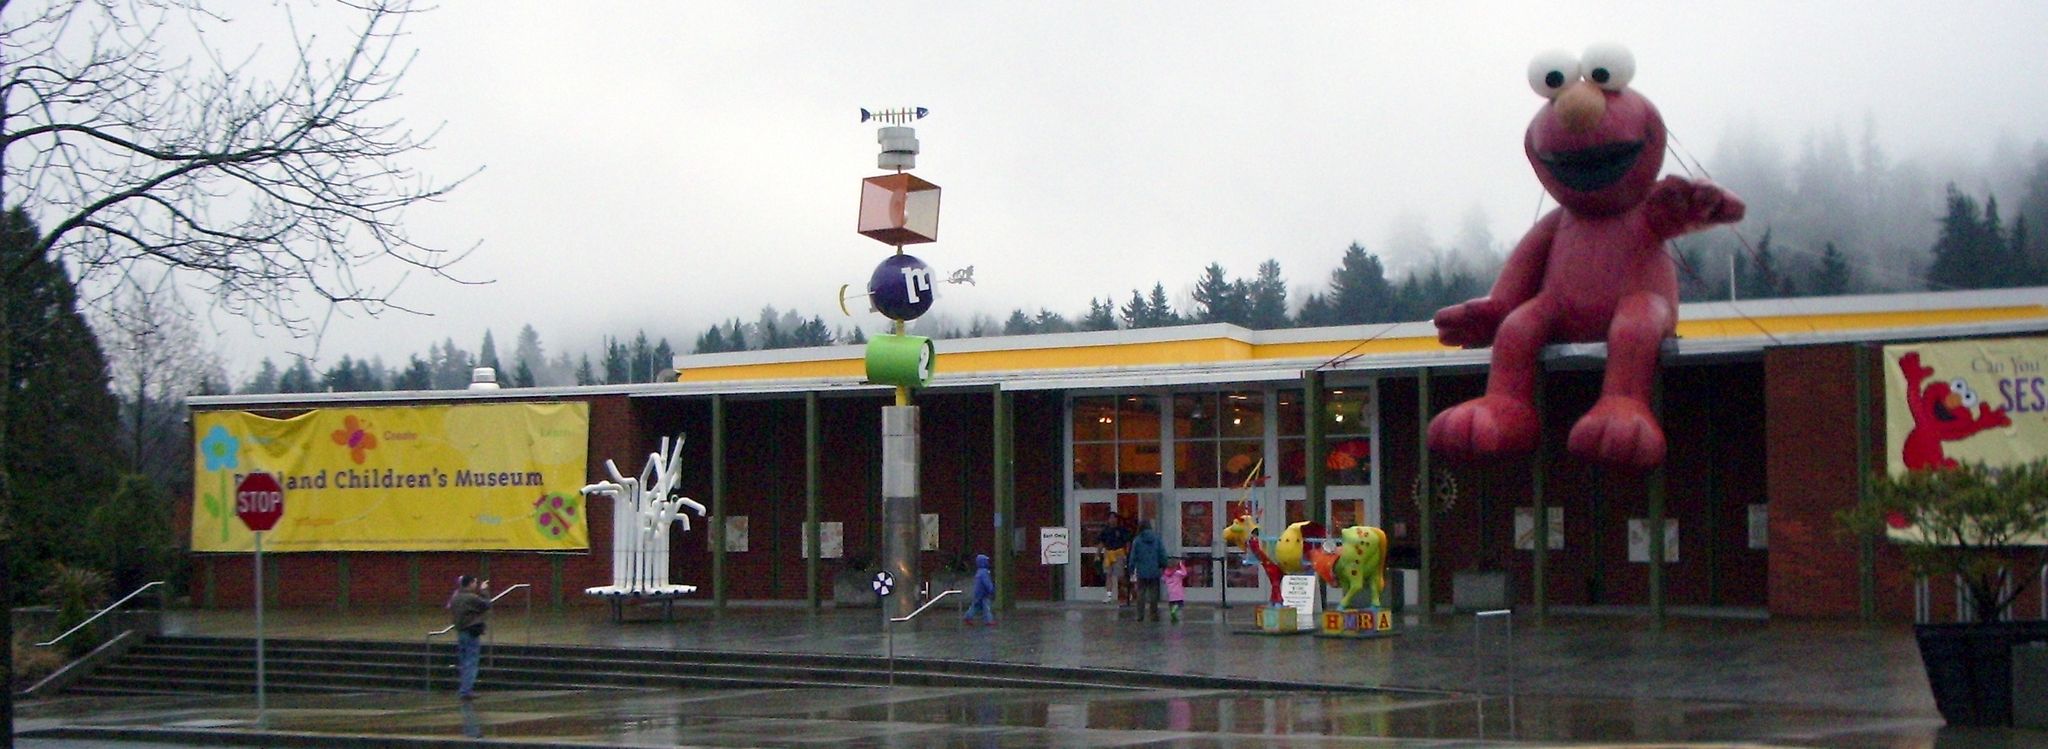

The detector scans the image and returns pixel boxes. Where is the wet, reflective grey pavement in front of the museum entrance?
[16,600,2048,749]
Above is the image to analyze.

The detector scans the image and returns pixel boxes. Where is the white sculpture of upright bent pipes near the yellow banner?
[584,434,705,598]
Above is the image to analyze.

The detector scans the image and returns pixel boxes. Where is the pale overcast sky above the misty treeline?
[188,0,2048,381]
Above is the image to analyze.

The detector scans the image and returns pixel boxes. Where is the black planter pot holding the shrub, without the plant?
[1913,622,2048,726]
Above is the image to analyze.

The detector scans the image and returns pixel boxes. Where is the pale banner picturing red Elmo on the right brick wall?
[1884,338,2048,475]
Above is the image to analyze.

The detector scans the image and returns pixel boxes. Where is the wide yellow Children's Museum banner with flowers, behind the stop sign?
[193,403,590,550]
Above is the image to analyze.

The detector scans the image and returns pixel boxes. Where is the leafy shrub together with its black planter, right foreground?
[1837,460,2048,724]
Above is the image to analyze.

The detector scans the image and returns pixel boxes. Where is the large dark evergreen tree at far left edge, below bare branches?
[0,209,121,604]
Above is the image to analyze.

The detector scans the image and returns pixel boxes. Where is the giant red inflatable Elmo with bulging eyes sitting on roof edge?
[1430,45,1743,469]
